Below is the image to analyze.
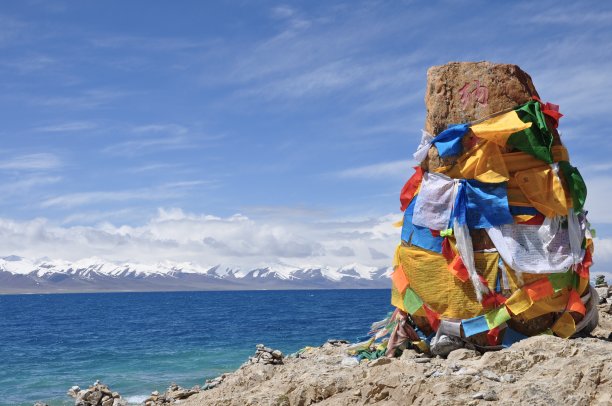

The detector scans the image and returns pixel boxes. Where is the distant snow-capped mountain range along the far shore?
[0,255,392,293]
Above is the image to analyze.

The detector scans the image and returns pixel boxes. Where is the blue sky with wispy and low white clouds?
[0,0,612,272]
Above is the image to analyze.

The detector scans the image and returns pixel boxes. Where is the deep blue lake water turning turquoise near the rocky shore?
[0,290,391,405]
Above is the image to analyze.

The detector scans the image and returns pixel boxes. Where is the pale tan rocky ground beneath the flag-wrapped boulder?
[181,304,612,406]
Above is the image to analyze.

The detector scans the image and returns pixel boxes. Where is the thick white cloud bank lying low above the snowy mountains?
[0,208,400,267]
